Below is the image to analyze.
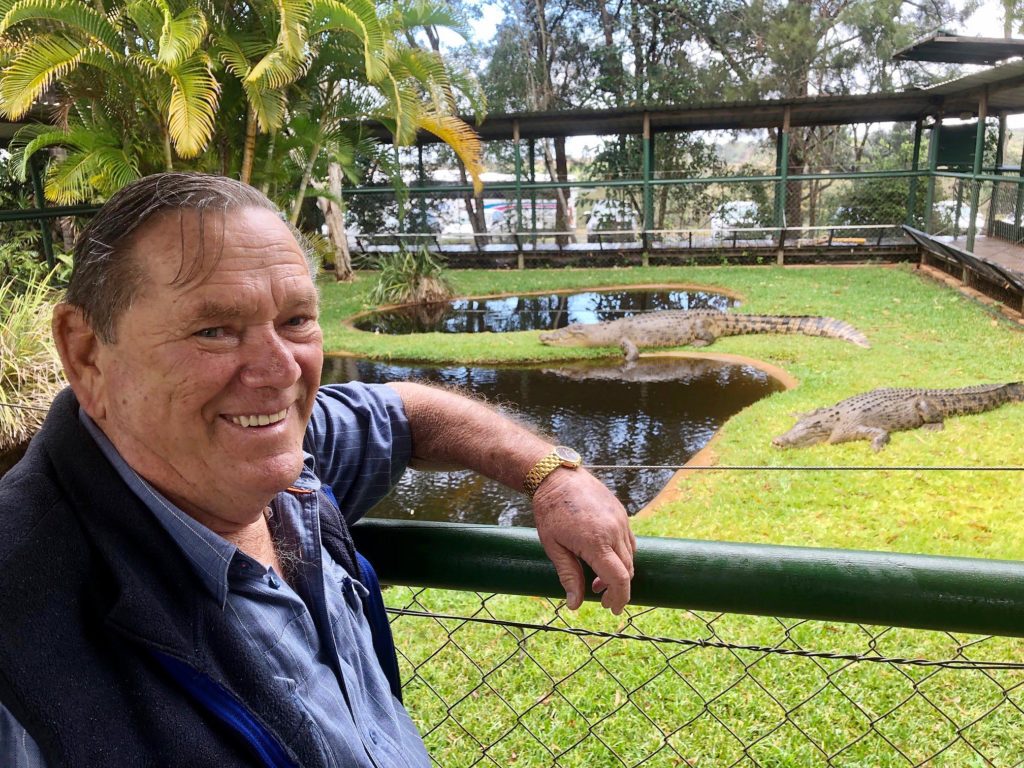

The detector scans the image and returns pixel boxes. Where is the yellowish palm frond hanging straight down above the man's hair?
[168,53,220,158]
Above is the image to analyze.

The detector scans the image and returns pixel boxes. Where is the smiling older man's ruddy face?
[97,208,323,529]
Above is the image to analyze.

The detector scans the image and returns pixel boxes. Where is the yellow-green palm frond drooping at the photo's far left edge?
[0,35,85,120]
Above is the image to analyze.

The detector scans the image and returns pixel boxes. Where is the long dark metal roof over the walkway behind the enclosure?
[389,61,1024,143]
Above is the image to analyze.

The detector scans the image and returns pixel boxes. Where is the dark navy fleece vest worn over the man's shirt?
[0,390,370,768]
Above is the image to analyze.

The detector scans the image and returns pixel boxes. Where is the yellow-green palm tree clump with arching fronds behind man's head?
[0,0,480,207]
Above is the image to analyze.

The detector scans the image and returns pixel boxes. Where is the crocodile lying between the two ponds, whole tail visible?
[540,309,870,362]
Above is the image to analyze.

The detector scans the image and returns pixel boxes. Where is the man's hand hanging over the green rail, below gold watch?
[534,469,637,615]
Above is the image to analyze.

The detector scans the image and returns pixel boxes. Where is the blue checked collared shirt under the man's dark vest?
[0,384,430,768]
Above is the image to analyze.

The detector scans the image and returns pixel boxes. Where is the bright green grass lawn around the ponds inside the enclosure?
[323,266,1024,766]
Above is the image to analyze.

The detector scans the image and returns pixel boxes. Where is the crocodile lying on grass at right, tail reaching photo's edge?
[772,381,1024,451]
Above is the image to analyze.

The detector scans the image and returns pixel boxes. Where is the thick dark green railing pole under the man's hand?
[352,520,1024,637]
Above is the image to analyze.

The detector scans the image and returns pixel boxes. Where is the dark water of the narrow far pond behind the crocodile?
[355,291,736,334]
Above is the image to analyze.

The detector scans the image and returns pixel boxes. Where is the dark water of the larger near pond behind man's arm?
[324,358,782,525]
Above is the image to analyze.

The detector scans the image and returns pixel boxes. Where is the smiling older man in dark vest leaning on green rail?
[0,173,636,768]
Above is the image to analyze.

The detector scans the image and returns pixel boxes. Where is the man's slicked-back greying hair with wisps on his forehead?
[65,173,316,344]
